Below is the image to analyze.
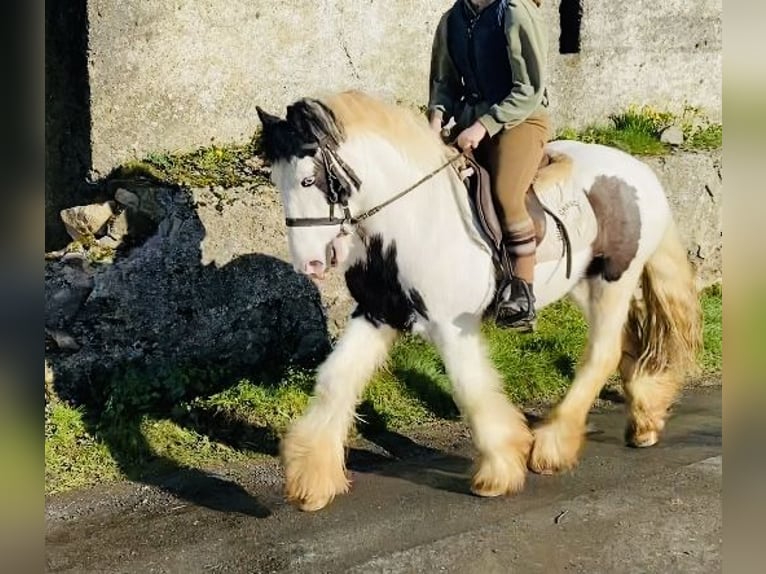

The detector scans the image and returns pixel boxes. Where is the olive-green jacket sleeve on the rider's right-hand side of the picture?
[479,0,548,136]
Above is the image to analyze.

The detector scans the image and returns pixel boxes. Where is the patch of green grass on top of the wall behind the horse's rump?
[556,106,723,155]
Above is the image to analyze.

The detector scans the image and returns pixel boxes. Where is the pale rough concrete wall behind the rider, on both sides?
[87,0,722,177]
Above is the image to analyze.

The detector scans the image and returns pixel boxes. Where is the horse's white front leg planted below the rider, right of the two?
[433,320,532,496]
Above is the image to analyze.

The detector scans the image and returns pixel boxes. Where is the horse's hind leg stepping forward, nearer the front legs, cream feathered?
[529,270,640,474]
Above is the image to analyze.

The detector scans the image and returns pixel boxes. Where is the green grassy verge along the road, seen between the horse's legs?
[45,286,722,494]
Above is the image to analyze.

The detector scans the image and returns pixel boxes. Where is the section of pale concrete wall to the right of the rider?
[547,0,722,127]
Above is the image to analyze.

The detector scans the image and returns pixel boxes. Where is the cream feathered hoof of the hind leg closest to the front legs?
[529,420,585,476]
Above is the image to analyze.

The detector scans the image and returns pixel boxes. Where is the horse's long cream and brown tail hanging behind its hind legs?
[626,222,702,378]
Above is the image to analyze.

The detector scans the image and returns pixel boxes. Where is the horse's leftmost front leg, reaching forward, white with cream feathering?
[280,317,396,511]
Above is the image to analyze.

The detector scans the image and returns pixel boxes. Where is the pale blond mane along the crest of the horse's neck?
[321,90,447,165]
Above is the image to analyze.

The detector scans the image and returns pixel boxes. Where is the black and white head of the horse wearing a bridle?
[257,99,359,279]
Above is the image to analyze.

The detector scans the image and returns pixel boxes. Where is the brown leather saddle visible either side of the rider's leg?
[458,153,572,278]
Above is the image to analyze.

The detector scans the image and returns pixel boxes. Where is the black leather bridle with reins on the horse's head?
[285,137,466,232]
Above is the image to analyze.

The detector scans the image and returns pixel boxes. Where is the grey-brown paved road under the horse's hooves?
[46,388,722,574]
